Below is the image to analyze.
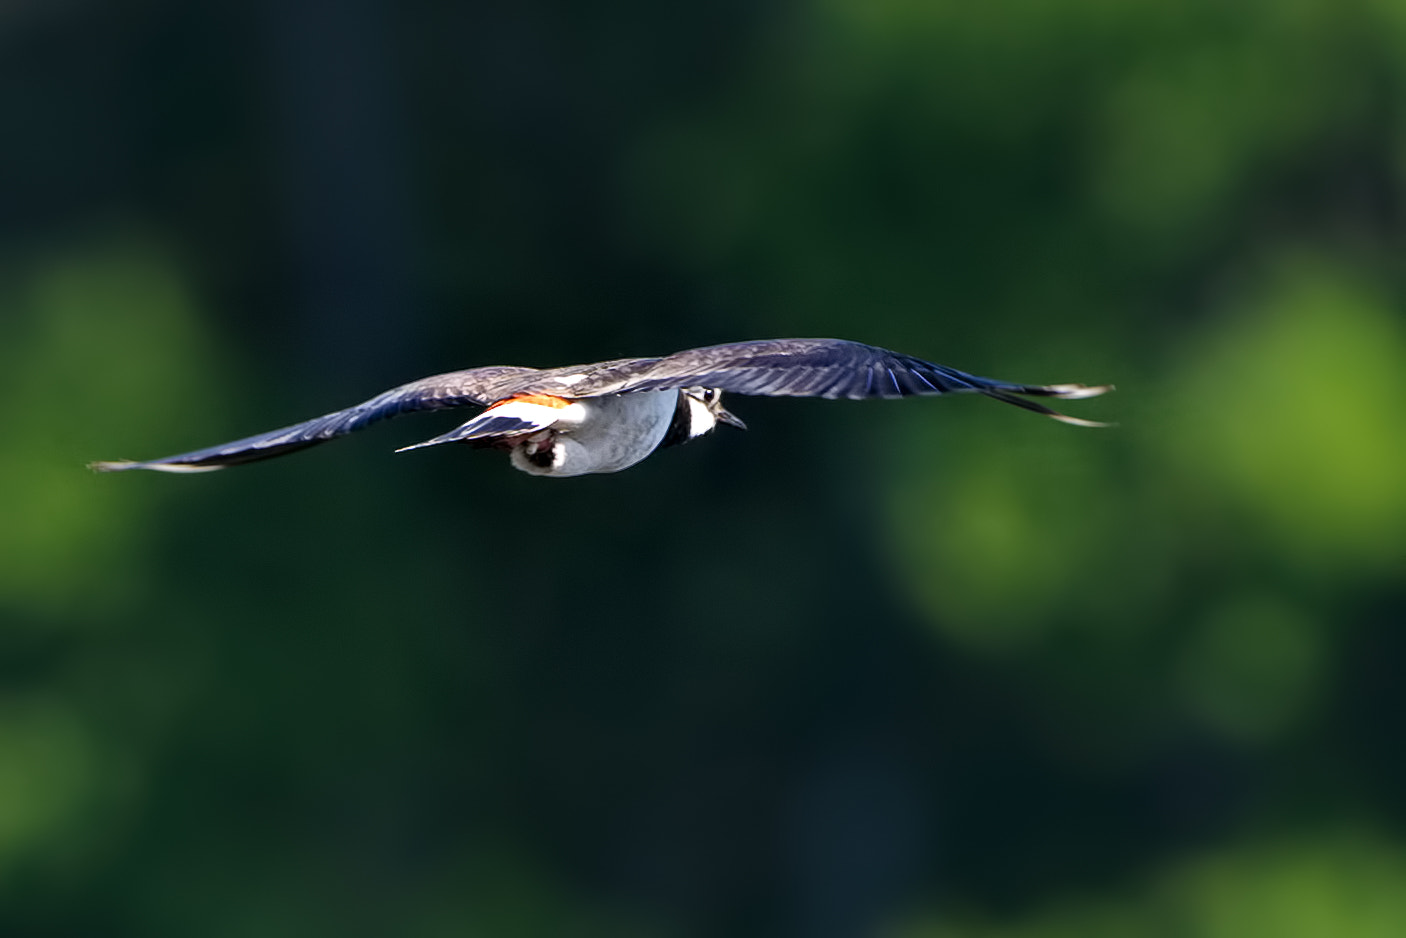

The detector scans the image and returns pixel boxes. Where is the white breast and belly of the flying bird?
[512,391,679,477]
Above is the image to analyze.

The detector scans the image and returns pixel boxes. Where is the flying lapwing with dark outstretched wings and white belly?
[89,339,1112,478]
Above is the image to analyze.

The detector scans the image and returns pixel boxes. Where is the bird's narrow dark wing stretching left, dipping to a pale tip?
[90,366,537,473]
